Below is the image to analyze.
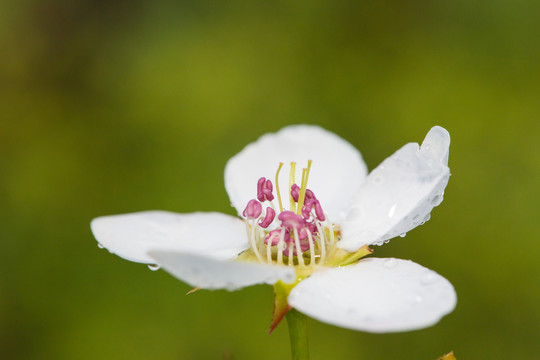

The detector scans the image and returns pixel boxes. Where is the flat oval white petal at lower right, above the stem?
[288,258,457,333]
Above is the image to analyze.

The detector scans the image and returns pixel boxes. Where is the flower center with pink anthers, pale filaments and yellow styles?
[243,160,339,267]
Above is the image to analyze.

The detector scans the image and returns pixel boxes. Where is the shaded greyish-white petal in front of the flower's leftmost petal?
[148,250,296,290]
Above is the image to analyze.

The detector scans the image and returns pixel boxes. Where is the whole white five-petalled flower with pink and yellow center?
[91,125,456,332]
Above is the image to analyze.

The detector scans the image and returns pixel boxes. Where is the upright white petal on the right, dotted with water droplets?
[339,126,450,251]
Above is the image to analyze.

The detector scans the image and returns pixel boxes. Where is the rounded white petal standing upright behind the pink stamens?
[225,125,367,222]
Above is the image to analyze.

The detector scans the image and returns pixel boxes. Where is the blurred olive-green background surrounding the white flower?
[0,0,540,360]
